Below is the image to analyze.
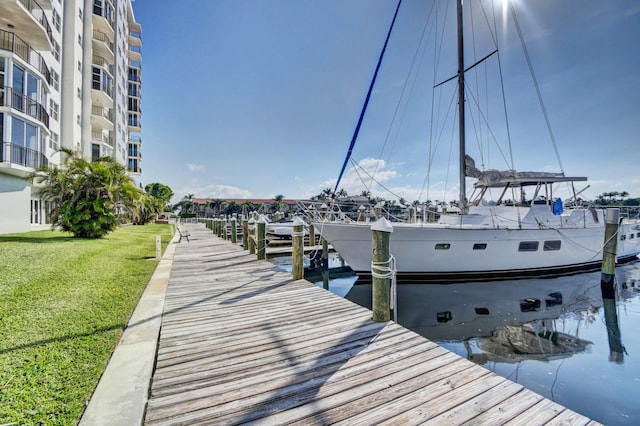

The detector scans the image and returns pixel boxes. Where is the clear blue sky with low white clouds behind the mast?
[134,0,640,201]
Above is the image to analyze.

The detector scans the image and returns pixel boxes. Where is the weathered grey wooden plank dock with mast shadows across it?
[145,225,597,425]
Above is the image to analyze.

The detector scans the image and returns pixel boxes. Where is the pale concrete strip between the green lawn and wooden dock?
[79,232,179,426]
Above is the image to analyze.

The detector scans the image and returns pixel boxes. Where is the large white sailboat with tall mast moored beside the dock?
[314,0,640,282]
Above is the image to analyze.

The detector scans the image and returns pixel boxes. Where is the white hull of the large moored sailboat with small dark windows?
[314,210,640,282]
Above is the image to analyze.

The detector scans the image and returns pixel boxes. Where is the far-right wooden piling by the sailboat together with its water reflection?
[600,209,624,363]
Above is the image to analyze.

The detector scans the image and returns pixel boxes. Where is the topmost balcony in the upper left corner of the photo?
[0,0,53,51]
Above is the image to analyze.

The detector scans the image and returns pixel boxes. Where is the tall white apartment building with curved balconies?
[0,0,142,234]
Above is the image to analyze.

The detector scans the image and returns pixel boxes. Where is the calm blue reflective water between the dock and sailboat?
[272,255,640,425]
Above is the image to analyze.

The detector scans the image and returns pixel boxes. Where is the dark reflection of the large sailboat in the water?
[346,266,640,365]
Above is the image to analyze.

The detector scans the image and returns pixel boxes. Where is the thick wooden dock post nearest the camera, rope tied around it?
[371,217,393,322]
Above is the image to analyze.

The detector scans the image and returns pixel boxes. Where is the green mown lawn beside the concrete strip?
[0,225,171,425]
